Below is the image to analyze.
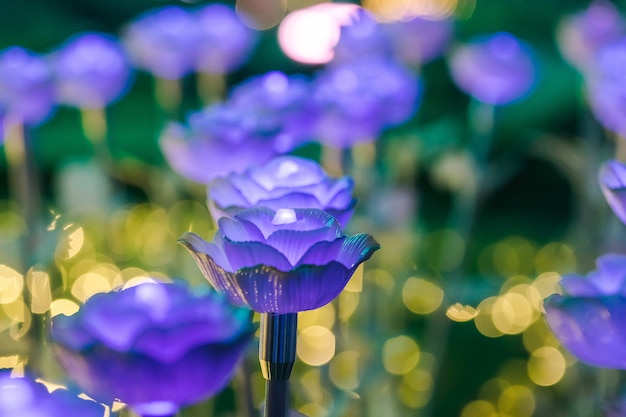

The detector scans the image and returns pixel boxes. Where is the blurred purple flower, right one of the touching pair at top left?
[195,3,258,74]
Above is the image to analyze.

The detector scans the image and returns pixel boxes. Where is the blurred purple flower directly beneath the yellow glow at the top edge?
[384,17,452,66]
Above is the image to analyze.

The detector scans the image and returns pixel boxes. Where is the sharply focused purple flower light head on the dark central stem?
[180,208,379,314]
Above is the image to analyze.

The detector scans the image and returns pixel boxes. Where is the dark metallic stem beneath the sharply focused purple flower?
[259,313,298,417]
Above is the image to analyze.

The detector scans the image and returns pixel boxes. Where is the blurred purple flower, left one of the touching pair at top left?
[124,6,199,80]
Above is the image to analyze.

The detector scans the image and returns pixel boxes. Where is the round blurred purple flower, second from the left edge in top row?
[53,33,131,109]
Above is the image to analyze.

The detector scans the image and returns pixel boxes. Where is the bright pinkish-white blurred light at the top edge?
[278,3,360,64]
